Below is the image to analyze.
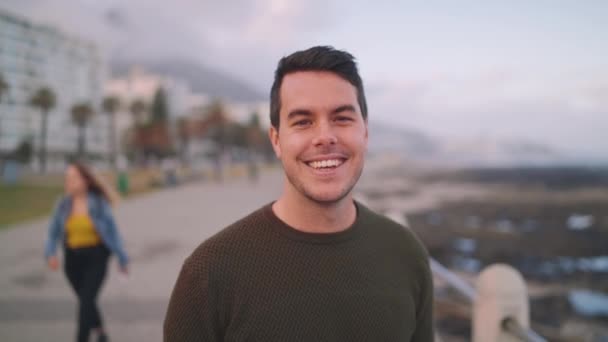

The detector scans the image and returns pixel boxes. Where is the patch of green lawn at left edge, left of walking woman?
[0,184,63,229]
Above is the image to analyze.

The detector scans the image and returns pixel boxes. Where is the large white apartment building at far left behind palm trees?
[0,10,109,170]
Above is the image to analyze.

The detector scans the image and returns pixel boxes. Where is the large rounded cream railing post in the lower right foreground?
[473,264,530,342]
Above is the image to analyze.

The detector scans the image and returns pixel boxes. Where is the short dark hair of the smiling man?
[270,46,367,129]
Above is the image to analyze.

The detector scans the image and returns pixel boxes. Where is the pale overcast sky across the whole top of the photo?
[0,0,608,159]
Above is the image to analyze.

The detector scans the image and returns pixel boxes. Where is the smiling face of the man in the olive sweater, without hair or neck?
[270,71,367,204]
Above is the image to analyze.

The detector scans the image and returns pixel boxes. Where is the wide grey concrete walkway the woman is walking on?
[0,171,282,342]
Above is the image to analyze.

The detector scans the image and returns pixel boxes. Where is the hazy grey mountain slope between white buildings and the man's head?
[111,59,268,102]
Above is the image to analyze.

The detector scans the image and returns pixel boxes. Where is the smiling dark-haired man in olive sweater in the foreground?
[164,46,433,341]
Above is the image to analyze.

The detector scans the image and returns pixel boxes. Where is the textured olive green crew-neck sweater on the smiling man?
[164,203,433,342]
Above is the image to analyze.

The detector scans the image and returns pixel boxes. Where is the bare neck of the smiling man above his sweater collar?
[272,185,357,233]
